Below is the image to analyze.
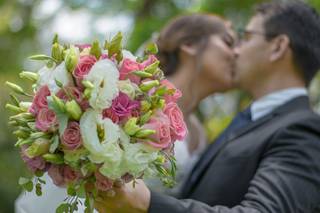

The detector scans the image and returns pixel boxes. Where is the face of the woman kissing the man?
[197,29,235,92]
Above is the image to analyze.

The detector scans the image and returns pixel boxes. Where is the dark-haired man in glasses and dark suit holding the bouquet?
[96,1,320,213]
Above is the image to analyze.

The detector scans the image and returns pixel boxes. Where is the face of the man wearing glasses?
[233,15,270,92]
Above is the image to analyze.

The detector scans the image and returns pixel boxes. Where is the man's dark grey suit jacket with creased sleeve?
[148,96,320,213]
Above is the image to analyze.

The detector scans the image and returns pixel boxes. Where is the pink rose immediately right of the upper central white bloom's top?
[119,58,142,84]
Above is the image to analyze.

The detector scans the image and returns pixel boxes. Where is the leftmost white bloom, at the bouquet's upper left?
[37,62,72,93]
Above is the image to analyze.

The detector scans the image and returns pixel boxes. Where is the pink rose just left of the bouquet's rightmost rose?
[143,111,171,149]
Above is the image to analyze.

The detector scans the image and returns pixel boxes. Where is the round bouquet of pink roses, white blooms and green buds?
[6,33,186,212]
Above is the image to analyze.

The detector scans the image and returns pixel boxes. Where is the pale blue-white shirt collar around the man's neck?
[250,87,308,121]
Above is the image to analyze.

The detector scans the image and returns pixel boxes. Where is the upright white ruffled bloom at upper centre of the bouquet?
[85,59,119,111]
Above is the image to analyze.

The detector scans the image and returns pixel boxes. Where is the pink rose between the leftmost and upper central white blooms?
[73,55,97,87]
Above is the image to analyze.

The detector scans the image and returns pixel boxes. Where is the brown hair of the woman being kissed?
[156,14,227,76]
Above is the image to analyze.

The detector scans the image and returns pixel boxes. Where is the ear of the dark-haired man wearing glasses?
[270,35,290,62]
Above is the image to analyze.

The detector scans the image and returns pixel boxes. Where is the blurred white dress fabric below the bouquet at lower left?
[15,174,97,213]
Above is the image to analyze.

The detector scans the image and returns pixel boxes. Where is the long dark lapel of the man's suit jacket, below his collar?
[181,96,310,197]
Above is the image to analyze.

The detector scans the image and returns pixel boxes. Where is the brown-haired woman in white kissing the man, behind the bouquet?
[147,14,234,195]
